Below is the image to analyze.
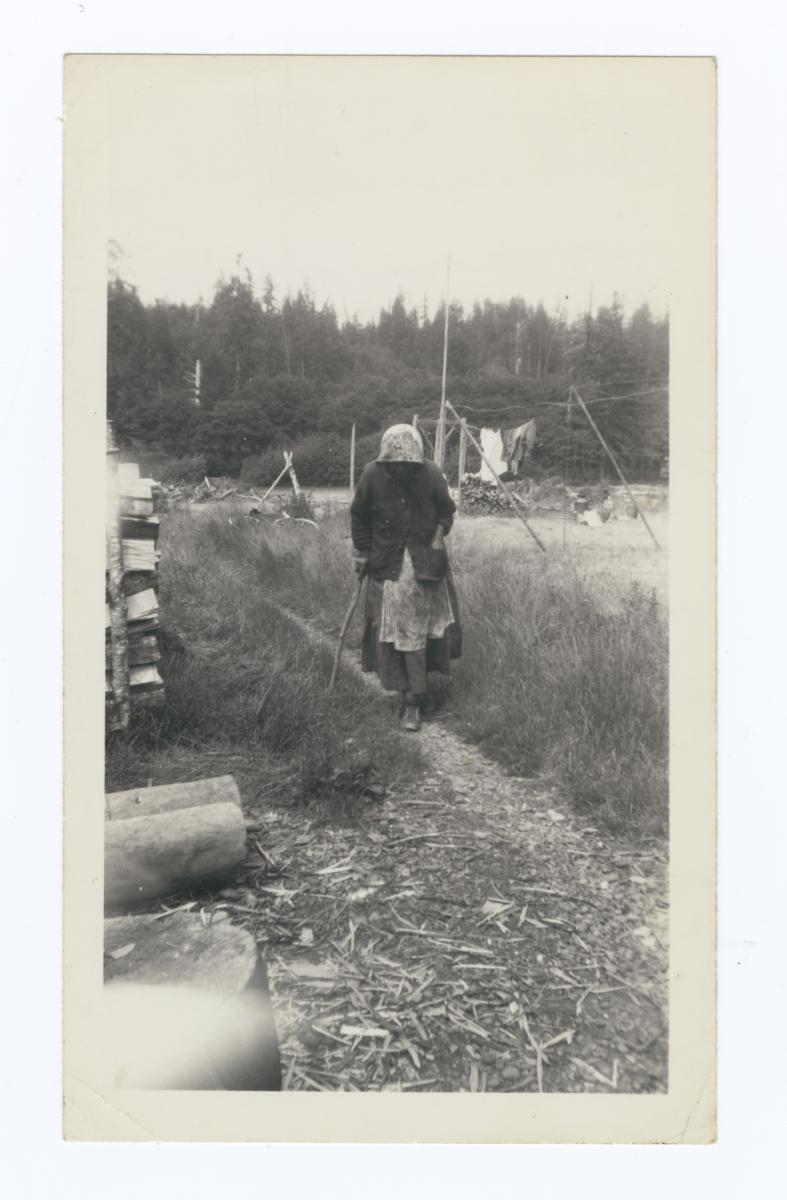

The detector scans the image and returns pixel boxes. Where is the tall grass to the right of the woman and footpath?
[455,546,668,833]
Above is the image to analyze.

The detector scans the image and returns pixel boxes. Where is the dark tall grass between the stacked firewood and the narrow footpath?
[107,512,417,812]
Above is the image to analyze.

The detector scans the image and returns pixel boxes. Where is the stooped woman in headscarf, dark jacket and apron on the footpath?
[350,425,461,732]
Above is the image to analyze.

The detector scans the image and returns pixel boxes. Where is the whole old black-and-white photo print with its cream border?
[65,55,715,1140]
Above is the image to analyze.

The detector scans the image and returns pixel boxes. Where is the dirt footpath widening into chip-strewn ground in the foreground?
[214,595,667,1092]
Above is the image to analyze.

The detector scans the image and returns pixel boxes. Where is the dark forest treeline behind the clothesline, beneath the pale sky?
[107,272,669,485]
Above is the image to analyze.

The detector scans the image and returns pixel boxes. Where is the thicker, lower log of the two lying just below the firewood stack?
[104,803,246,912]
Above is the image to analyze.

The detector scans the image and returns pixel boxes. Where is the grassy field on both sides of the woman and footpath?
[108,505,668,834]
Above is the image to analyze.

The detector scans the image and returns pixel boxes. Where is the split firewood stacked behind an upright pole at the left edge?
[104,451,164,730]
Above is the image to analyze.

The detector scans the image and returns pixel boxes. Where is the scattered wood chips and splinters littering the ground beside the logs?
[223,748,660,1092]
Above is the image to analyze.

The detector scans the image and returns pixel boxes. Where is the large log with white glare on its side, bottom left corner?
[102,912,281,1091]
